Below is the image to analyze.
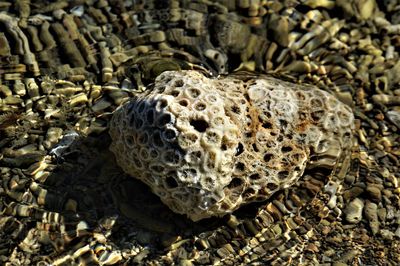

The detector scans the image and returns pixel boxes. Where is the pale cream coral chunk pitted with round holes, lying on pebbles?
[110,71,353,221]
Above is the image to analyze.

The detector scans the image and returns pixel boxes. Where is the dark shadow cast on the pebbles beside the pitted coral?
[43,133,234,258]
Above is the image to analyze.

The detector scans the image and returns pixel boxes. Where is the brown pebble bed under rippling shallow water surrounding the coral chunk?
[0,0,400,265]
